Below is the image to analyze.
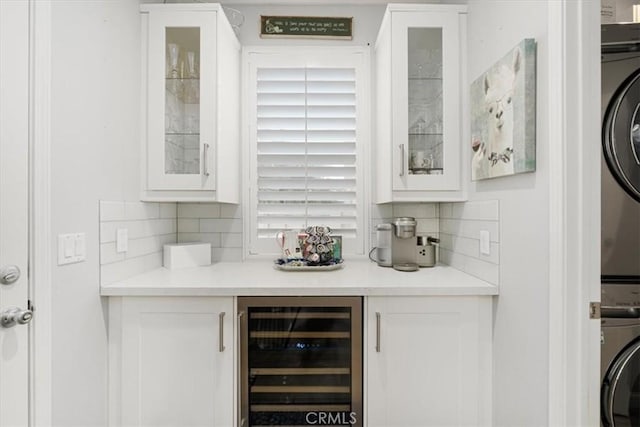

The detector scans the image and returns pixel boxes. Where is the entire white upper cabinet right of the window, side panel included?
[375,4,466,203]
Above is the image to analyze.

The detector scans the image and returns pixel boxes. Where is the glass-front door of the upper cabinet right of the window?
[391,11,462,191]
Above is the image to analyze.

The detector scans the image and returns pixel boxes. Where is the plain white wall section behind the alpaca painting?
[466,0,550,427]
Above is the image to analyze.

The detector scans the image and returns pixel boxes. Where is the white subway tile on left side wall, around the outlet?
[100,201,177,285]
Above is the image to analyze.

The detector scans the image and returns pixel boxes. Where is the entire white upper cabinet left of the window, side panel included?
[141,4,240,203]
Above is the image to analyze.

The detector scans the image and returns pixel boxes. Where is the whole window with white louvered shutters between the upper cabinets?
[245,49,369,254]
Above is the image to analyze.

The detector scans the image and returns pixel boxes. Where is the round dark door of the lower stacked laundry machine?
[601,338,640,427]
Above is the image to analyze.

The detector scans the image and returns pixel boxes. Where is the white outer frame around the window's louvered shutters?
[241,46,373,259]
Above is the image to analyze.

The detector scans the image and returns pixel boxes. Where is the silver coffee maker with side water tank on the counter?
[375,217,419,271]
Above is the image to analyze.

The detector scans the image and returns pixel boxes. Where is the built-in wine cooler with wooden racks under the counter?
[238,297,363,427]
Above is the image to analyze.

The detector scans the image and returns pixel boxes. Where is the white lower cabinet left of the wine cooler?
[109,297,234,427]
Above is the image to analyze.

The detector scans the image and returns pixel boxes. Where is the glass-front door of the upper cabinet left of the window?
[146,11,216,190]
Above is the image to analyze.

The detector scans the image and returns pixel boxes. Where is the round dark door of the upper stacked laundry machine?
[602,70,640,202]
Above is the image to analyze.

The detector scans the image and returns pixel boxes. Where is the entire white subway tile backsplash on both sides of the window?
[100,200,500,285]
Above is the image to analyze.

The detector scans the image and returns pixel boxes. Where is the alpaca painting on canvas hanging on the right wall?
[471,39,536,181]
